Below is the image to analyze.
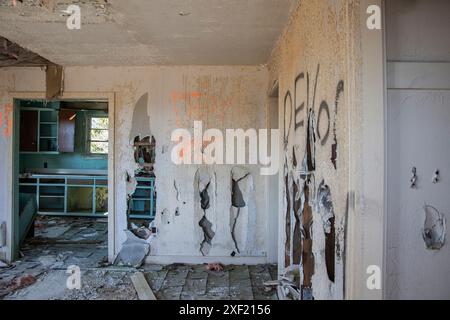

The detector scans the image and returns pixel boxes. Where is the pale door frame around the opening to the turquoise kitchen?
[6,91,116,262]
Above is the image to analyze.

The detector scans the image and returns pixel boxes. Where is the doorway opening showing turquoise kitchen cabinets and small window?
[13,99,113,267]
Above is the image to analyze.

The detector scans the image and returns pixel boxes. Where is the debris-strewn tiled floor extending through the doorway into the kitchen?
[0,217,277,300]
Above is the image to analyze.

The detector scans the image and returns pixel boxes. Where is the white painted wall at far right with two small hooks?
[386,0,450,299]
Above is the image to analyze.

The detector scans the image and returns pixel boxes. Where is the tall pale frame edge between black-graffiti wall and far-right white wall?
[345,0,386,300]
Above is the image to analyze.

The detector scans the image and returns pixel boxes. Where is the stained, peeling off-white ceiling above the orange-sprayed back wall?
[0,0,297,66]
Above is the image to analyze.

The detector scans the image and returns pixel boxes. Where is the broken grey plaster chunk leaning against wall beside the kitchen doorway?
[114,230,150,268]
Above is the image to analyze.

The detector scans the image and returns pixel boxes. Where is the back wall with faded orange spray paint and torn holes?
[0,66,270,263]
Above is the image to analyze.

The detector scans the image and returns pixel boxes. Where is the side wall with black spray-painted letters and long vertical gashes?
[268,0,360,299]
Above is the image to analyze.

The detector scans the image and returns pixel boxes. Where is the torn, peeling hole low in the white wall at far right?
[422,204,446,250]
